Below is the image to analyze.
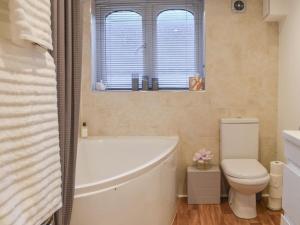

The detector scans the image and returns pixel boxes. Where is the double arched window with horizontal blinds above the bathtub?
[94,0,204,90]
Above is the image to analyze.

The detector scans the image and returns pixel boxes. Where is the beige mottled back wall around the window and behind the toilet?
[81,0,278,194]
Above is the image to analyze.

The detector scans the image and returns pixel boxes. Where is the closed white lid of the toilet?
[222,159,268,179]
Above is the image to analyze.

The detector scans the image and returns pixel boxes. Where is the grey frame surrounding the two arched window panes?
[92,0,205,90]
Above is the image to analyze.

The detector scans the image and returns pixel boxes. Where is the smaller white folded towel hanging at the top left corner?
[9,0,53,50]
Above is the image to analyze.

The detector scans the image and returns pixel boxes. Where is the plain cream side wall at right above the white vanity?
[278,0,300,160]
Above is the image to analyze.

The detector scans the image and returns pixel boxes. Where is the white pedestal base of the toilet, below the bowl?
[228,188,257,219]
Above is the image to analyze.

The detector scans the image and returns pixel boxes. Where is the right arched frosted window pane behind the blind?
[155,10,198,88]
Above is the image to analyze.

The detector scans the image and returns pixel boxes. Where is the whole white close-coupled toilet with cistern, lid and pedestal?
[220,118,270,219]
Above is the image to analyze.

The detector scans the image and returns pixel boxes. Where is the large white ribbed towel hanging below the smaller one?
[0,39,62,225]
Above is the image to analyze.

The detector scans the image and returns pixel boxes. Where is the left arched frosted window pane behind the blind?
[101,11,144,89]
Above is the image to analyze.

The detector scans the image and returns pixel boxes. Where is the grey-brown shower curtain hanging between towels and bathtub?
[51,0,82,225]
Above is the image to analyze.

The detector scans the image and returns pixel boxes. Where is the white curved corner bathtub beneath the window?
[71,137,178,225]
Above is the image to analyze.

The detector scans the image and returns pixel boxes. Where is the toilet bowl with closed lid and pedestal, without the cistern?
[221,159,270,219]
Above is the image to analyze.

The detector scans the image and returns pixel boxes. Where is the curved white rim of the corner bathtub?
[74,136,179,198]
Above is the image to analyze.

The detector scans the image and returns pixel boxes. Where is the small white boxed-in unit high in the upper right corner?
[263,0,289,22]
